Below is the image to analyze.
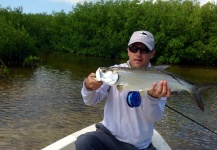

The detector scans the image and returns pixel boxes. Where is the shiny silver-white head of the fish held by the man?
[95,67,118,85]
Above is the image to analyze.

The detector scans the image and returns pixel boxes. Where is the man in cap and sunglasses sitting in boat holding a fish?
[76,31,170,150]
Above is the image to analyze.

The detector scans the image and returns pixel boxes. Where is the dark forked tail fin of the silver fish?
[191,83,217,111]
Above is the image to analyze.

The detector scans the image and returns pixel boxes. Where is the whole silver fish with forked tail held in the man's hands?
[95,67,217,111]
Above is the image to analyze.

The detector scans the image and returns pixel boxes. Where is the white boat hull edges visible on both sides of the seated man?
[42,124,171,150]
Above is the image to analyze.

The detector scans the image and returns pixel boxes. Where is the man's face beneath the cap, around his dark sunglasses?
[128,43,155,68]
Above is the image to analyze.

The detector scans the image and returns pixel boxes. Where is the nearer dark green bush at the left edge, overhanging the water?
[0,6,35,65]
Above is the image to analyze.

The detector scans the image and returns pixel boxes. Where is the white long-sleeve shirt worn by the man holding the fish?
[81,61,166,149]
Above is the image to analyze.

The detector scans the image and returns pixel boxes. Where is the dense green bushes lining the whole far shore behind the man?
[0,0,217,65]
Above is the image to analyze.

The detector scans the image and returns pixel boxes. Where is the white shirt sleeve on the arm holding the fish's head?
[81,81,110,106]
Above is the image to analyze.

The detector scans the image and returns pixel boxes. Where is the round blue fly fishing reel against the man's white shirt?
[127,91,141,108]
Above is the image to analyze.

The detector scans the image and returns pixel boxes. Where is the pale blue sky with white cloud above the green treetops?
[0,0,214,14]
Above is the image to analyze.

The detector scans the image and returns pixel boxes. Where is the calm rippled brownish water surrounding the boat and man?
[0,56,217,150]
